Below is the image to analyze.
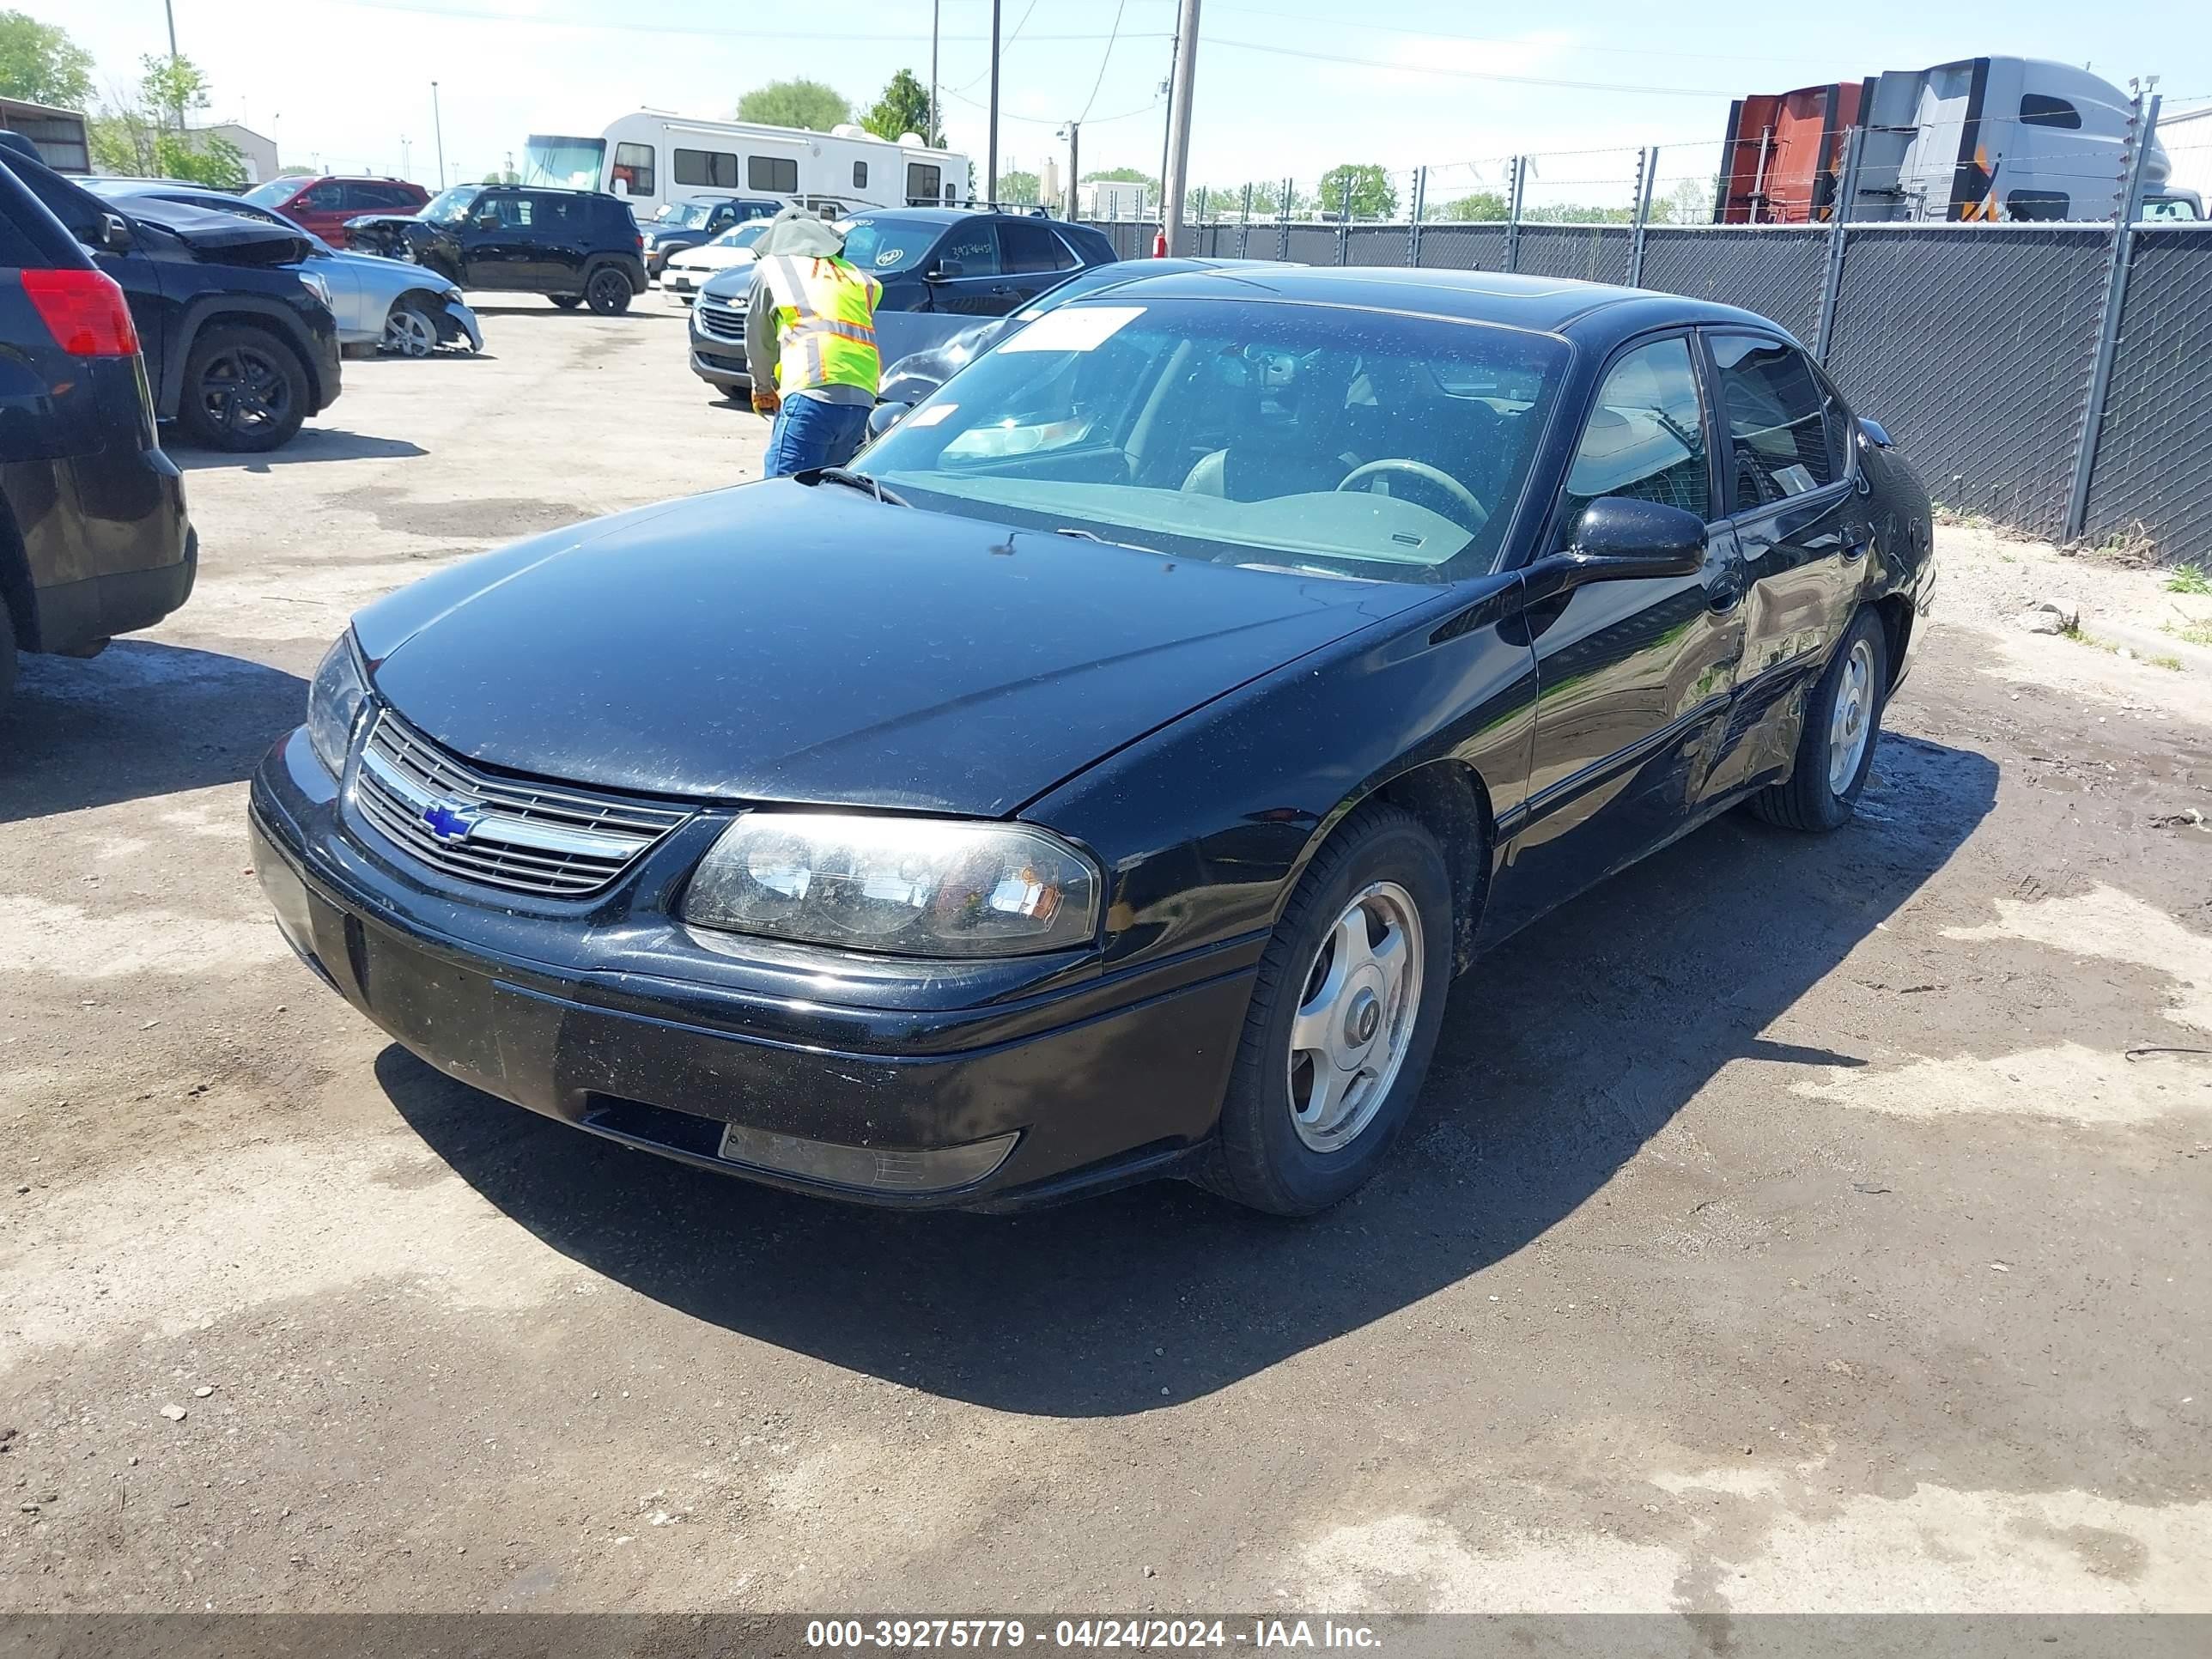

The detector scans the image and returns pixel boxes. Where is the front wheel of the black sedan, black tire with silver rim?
[1197,803,1451,1217]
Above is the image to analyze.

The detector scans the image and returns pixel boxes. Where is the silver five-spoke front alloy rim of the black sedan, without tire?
[1290,880,1422,1152]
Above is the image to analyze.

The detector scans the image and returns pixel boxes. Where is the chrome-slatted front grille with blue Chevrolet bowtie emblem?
[354,710,690,898]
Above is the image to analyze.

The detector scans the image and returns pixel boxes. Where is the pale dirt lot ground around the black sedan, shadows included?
[0,301,2212,1613]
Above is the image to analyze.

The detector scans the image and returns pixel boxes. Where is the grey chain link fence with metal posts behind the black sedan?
[1097,216,2212,562]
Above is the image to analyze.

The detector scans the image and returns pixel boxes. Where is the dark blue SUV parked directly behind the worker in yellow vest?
[690,208,1115,398]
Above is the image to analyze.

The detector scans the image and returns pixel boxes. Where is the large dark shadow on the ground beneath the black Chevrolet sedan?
[376,737,1997,1416]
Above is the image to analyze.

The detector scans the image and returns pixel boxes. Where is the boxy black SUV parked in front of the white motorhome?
[345,184,646,316]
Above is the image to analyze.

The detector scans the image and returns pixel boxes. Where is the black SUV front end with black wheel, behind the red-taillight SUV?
[0,135,338,452]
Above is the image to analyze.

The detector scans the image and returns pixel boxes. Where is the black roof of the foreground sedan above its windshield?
[1071,258,1787,345]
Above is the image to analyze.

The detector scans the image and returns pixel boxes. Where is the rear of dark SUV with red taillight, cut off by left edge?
[0,166,199,708]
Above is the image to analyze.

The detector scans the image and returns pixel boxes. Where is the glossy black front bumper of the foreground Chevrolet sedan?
[250,732,1259,1207]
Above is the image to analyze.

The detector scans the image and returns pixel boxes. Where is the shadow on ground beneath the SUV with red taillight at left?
[0,639,307,823]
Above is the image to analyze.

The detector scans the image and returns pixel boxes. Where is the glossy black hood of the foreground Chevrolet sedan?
[356,480,1425,817]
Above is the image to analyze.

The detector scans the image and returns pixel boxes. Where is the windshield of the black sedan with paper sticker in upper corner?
[848,298,1566,581]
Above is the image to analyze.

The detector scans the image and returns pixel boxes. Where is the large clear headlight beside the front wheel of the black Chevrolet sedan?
[684,811,1102,956]
